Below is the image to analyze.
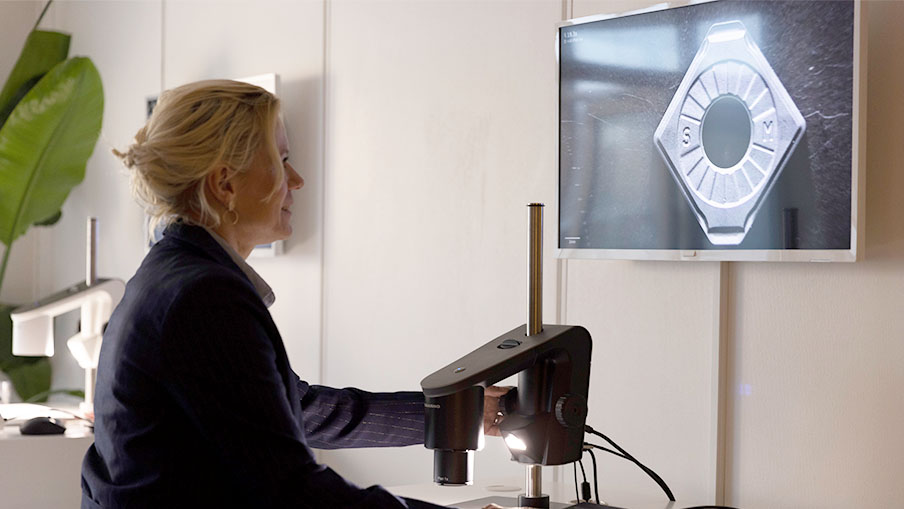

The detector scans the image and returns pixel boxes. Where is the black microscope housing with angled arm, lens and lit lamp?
[421,325,591,485]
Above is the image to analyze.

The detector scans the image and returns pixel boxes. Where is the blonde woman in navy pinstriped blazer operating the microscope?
[82,81,504,508]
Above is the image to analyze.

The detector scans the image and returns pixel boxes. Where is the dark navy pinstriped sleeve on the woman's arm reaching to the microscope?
[297,380,424,449]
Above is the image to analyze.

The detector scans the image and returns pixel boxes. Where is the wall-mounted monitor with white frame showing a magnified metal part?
[558,0,862,261]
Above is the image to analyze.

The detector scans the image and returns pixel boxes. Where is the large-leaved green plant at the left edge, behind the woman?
[0,0,104,401]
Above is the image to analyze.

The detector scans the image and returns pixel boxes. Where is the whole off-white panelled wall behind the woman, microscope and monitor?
[0,0,904,508]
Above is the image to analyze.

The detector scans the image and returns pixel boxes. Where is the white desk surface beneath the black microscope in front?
[387,476,712,509]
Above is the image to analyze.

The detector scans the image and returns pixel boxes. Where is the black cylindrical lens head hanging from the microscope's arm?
[424,385,483,485]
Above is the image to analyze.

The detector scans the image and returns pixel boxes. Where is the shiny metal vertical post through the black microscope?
[518,203,543,504]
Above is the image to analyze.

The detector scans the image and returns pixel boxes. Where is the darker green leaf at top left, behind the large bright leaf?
[0,30,71,126]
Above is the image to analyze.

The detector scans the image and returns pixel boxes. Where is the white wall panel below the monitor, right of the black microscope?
[566,260,719,501]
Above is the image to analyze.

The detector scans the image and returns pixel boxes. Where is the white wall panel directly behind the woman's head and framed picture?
[163,0,324,392]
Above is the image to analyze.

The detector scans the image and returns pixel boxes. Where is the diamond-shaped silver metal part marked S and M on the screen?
[653,21,806,245]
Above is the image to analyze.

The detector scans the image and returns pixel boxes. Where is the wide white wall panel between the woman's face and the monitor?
[324,1,562,484]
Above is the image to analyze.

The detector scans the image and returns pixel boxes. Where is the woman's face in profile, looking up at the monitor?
[231,120,304,252]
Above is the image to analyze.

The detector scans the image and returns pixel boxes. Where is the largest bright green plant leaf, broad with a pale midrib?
[0,57,104,246]
